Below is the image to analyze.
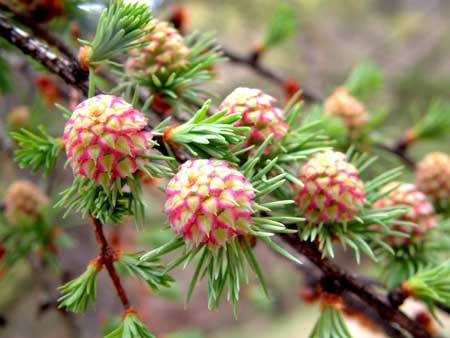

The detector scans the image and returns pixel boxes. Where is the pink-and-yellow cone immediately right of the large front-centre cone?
[294,150,365,224]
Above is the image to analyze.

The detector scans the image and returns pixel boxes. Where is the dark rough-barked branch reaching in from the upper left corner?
[0,14,88,95]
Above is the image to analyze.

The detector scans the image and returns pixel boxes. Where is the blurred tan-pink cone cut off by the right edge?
[415,152,450,204]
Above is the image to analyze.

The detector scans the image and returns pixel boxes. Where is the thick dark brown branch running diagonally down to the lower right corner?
[280,234,431,338]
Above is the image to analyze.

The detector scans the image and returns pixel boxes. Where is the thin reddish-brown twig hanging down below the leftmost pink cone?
[90,215,131,311]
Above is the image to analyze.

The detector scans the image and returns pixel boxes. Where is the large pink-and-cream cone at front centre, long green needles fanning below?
[164,159,255,247]
